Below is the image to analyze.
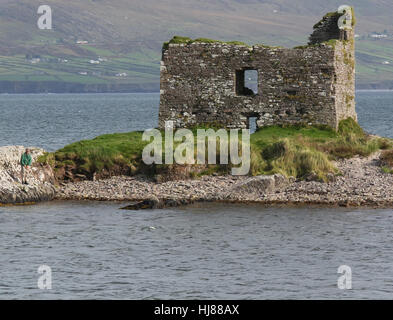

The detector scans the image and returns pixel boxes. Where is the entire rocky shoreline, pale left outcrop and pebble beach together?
[0,146,393,209]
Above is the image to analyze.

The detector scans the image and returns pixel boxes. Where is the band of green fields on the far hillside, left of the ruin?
[0,46,160,84]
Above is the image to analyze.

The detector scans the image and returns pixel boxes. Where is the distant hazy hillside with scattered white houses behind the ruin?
[0,0,393,92]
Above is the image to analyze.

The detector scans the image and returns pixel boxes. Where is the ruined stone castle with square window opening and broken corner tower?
[159,12,357,129]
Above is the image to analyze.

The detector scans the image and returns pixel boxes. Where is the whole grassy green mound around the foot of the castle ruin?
[39,118,393,181]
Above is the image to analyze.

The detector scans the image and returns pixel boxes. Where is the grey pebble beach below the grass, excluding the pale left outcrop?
[55,153,393,209]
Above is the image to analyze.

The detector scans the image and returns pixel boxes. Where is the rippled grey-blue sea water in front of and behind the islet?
[0,91,393,299]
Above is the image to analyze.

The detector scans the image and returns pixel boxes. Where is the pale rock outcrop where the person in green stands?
[0,146,56,204]
